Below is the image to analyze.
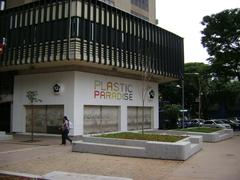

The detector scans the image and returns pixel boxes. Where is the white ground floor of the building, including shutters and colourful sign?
[12,71,158,135]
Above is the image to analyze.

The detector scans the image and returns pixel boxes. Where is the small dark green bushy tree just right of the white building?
[163,104,180,129]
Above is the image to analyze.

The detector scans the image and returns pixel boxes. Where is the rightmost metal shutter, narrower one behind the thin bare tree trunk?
[128,107,152,130]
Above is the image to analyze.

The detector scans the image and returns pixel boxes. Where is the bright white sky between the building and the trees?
[156,0,240,63]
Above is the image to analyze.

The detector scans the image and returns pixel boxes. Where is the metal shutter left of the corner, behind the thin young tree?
[26,105,64,134]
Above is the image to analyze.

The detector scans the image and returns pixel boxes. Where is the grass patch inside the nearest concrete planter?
[96,132,186,142]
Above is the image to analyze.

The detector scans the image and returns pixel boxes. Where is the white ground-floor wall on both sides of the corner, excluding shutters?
[12,72,158,135]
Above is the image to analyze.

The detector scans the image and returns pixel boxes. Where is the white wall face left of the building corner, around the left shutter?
[12,72,74,132]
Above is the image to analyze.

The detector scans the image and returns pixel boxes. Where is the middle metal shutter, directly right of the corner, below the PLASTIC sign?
[84,106,119,134]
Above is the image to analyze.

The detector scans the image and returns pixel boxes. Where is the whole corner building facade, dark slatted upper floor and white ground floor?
[0,0,184,136]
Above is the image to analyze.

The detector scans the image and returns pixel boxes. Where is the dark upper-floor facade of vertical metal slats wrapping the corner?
[0,0,184,78]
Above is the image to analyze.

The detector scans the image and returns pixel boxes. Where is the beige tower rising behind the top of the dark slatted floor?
[6,0,156,24]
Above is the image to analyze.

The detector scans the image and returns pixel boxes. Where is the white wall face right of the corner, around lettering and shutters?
[75,72,158,134]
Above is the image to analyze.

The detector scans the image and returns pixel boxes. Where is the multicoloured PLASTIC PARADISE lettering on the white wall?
[94,80,133,101]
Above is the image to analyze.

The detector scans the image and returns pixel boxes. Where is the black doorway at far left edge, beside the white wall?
[0,102,11,133]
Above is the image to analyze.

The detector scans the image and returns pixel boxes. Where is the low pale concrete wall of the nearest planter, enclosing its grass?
[72,136,202,160]
